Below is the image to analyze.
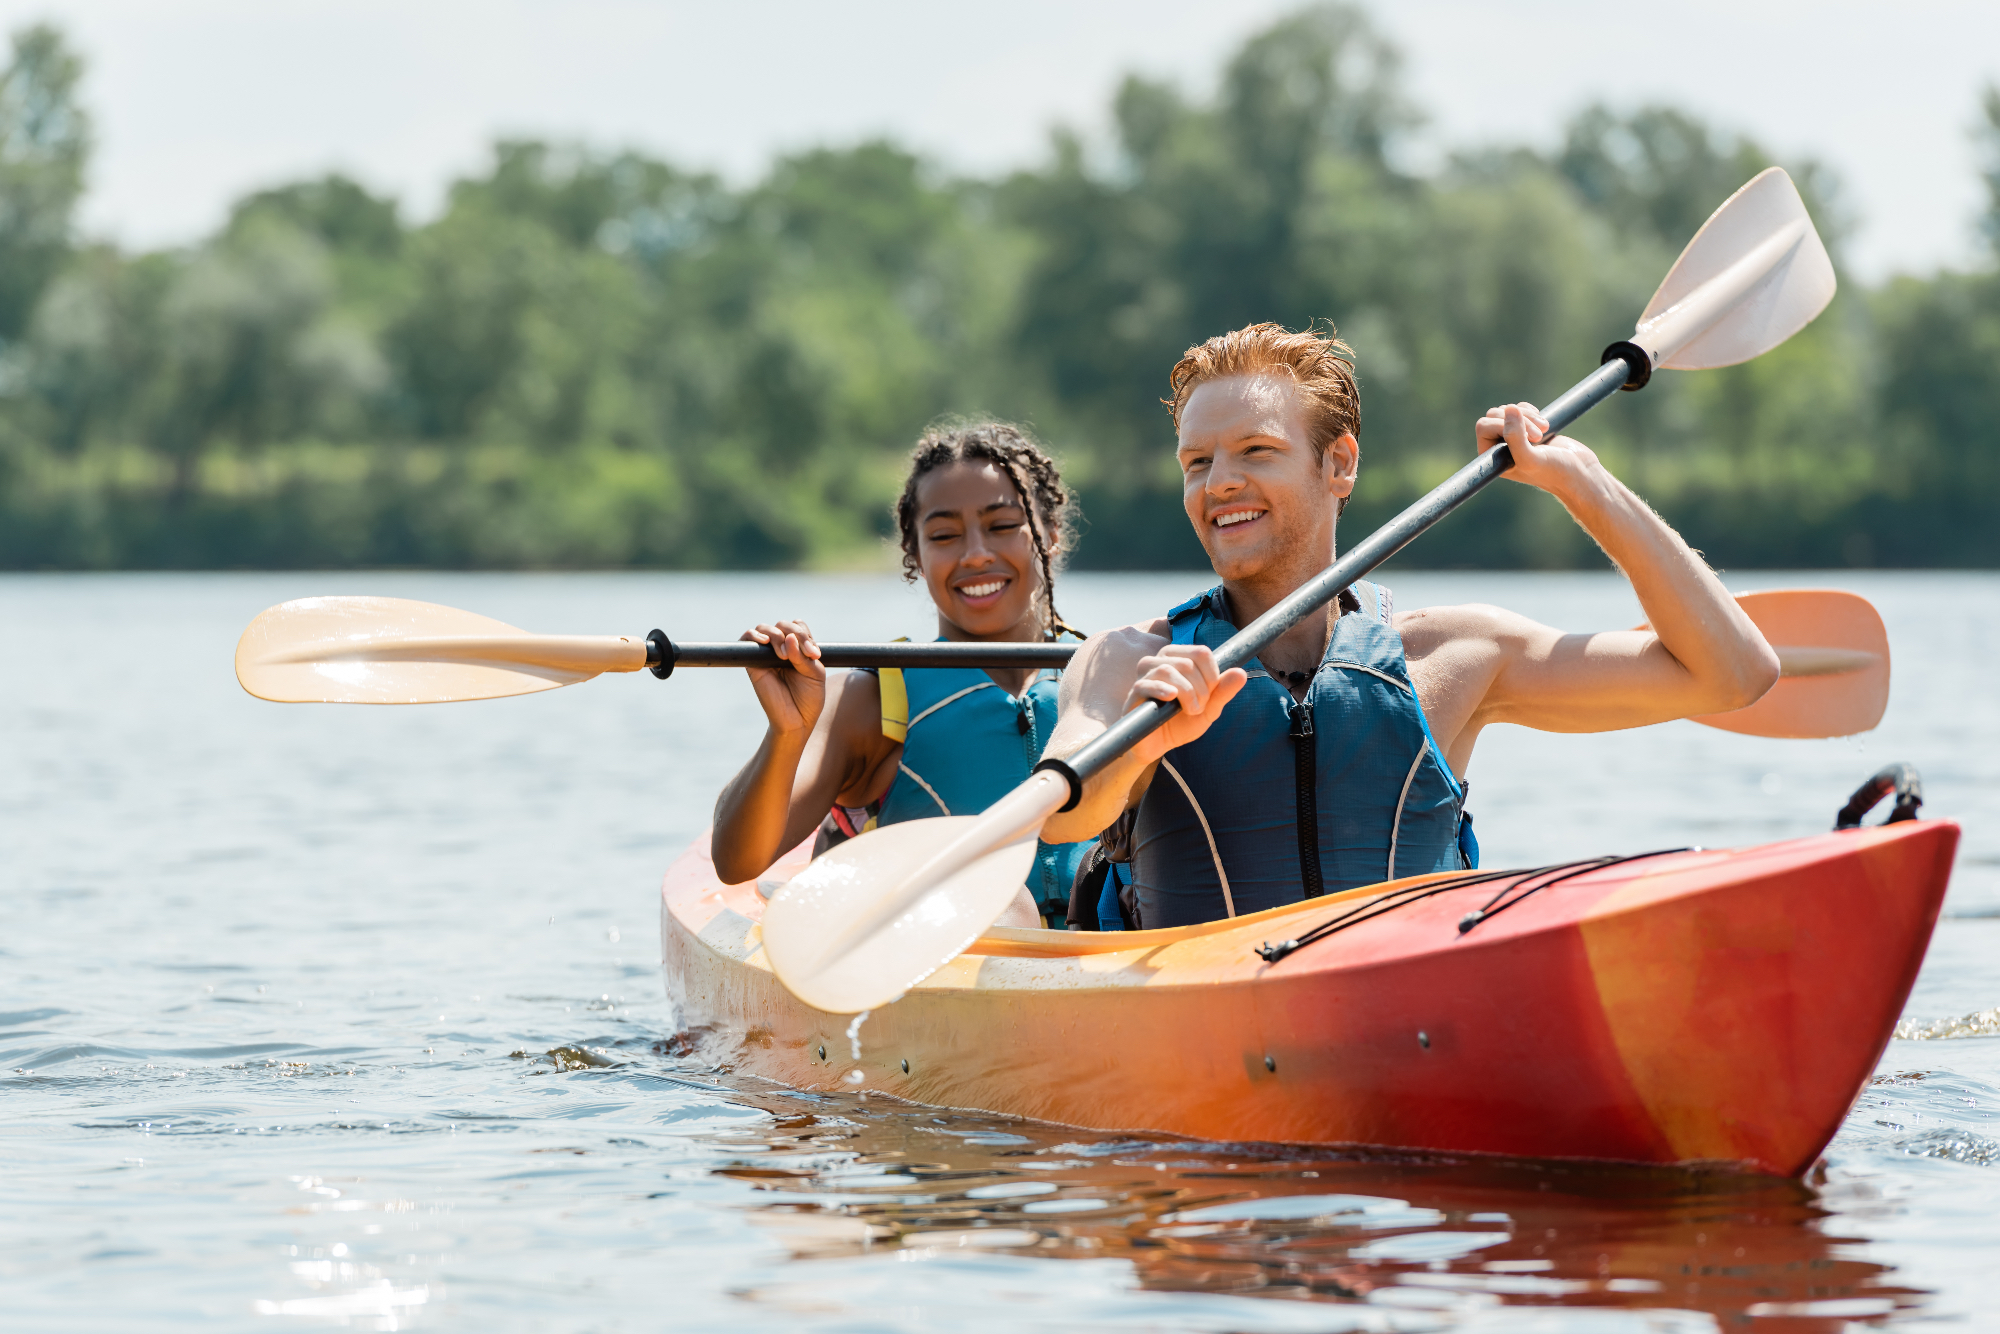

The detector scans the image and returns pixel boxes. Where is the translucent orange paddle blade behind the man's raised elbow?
[1694,588,1890,738]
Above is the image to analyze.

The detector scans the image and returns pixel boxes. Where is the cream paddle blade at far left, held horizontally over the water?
[236,598,646,704]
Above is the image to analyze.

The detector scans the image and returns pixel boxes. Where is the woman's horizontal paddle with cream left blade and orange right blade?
[236,588,1888,736]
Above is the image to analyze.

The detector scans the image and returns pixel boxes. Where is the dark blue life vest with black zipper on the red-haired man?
[1132,582,1478,928]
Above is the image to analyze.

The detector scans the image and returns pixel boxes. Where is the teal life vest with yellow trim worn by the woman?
[876,668,1096,924]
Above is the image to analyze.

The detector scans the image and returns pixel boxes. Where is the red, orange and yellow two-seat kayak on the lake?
[660,820,1958,1176]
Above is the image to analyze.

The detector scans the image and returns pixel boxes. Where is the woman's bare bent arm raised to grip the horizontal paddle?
[710,620,896,884]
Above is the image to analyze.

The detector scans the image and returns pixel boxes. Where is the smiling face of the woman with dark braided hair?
[916,462,1042,638]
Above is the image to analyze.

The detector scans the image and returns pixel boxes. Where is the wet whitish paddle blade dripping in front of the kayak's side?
[764,816,1034,1014]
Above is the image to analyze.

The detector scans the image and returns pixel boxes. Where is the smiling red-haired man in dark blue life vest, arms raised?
[1042,324,1778,928]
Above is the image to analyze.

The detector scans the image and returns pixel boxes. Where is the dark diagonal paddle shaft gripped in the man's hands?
[1036,342,1652,810]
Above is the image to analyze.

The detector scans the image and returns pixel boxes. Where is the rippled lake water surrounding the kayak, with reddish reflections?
[0,574,2000,1332]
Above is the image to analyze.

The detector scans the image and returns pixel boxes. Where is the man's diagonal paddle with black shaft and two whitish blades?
[764,168,1834,1012]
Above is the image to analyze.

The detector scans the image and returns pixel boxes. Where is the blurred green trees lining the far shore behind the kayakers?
[0,6,2000,568]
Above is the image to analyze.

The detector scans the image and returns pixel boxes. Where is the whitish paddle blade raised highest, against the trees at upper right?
[1632,166,1834,370]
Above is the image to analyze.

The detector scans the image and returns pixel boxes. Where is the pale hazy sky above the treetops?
[0,0,2000,280]
